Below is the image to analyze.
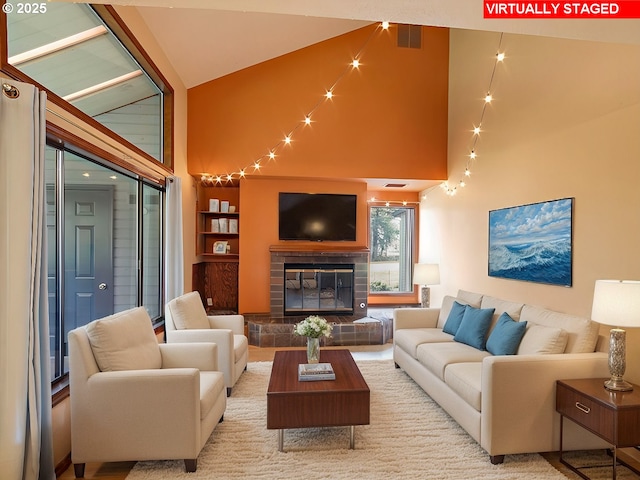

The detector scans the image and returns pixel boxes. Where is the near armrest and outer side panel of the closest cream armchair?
[71,368,201,454]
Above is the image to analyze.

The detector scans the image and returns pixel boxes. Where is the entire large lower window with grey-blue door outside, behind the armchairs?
[45,141,163,381]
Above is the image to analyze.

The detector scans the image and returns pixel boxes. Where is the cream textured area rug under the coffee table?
[127,360,567,480]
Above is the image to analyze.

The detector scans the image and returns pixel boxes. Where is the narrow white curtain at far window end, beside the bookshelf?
[164,177,184,302]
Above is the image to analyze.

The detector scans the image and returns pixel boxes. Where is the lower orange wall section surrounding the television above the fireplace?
[238,178,368,313]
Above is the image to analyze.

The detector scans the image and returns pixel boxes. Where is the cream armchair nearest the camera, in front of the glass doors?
[69,307,227,478]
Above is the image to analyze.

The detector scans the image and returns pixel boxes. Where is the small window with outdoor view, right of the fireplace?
[369,206,415,294]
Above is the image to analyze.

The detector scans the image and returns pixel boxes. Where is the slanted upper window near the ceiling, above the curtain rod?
[3,3,172,166]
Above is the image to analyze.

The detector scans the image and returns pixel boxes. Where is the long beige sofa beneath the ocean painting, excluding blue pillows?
[393,290,609,463]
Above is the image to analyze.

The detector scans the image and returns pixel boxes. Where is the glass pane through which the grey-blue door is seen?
[63,152,138,374]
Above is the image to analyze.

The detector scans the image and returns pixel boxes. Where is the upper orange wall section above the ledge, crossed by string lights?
[187,25,449,185]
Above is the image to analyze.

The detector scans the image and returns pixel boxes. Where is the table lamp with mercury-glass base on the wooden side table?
[591,280,640,392]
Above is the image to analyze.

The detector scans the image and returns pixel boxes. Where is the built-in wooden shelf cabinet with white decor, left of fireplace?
[193,185,240,313]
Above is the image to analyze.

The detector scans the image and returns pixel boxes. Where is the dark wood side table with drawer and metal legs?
[556,378,640,480]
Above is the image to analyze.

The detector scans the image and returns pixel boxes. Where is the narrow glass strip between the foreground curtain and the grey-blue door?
[44,147,58,380]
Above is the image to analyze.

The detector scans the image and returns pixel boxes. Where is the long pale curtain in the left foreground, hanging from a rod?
[0,78,55,480]
